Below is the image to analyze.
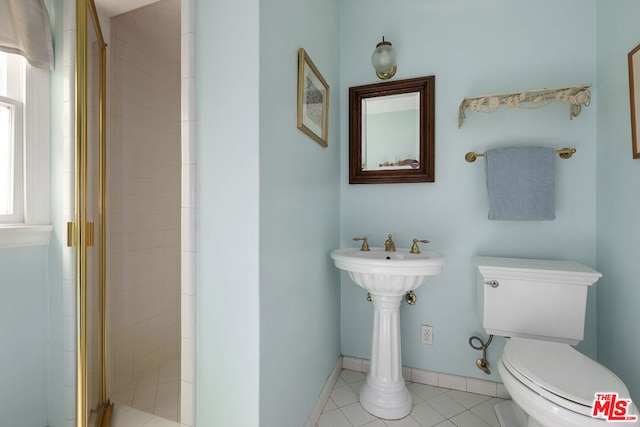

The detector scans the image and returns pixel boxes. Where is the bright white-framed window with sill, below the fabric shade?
[0,52,51,248]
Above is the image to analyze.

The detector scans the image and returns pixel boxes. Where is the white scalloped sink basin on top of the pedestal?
[331,248,444,295]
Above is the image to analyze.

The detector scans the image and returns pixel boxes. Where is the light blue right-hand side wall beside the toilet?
[597,0,640,404]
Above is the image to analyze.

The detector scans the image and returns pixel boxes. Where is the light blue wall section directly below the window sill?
[0,246,48,427]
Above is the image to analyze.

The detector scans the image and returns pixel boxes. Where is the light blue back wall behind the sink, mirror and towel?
[340,0,599,379]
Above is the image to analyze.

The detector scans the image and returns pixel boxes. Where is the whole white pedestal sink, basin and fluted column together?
[331,248,444,420]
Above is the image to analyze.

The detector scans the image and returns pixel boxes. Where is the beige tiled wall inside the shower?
[107,0,181,388]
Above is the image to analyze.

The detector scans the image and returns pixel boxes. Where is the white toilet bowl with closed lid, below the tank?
[496,338,639,427]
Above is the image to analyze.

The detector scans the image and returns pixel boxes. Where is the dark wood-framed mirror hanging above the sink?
[349,76,435,184]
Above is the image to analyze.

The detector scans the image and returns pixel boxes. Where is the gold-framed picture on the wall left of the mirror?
[298,48,329,147]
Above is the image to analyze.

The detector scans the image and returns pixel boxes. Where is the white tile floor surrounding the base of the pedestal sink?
[316,370,504,427]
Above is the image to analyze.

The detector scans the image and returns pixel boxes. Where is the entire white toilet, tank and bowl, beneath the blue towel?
[474,257,640,427]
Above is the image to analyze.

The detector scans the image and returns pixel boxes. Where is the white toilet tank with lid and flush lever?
[473,257,602,345]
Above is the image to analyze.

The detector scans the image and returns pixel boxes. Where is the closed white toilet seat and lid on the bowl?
[502,338,629,417]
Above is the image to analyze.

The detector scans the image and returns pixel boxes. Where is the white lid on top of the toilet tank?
[473,256,602,285]
